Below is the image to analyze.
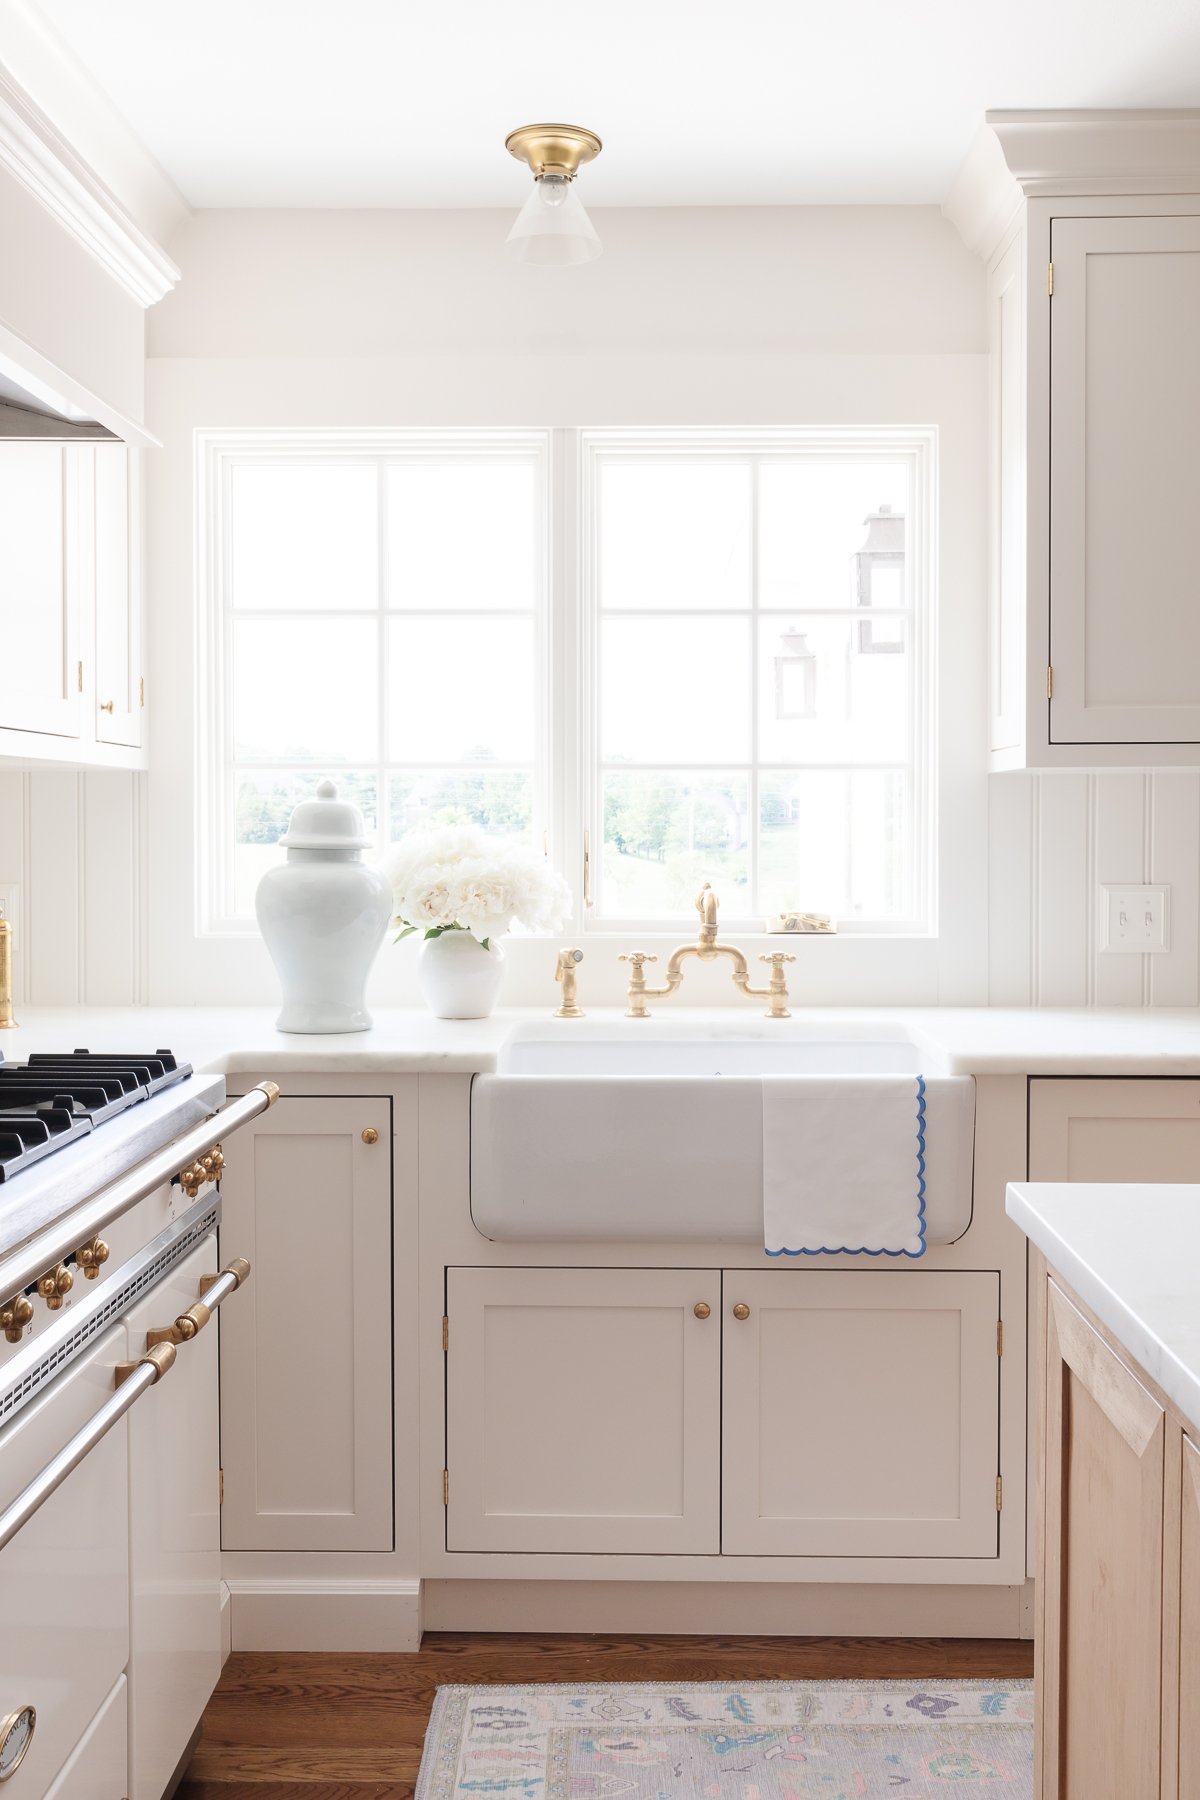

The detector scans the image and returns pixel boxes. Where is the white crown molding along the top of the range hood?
[0,65,180,306]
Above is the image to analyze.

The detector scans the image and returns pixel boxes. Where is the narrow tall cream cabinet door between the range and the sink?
[221,1096,392,1550]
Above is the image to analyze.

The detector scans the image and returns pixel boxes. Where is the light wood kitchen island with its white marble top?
[1007,1183,1200,1800]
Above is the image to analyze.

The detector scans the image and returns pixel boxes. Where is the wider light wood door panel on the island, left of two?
[1036,1282,1166,1800]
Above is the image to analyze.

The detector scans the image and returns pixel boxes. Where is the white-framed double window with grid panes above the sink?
[198,428,936,932]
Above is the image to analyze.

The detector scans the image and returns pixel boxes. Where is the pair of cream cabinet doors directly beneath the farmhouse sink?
[446,1269,999,1559]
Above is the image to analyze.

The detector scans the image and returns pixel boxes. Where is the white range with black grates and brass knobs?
[0,1049,277,1800]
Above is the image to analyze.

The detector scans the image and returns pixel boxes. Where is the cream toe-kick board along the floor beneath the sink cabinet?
[425,1580,1024,1638]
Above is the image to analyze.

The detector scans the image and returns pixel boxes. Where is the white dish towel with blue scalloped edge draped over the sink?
[763,1075,975,1256]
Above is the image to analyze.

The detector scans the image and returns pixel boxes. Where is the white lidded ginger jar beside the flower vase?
[254,781,392,1031]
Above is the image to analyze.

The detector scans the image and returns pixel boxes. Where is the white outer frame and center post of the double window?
[194,427,937,941]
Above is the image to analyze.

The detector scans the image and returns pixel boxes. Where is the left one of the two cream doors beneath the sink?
[446,1269,721,1553]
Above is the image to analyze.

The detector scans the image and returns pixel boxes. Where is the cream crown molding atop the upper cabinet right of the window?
[943,108,1200,257]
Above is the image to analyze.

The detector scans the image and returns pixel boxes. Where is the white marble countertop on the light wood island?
[1007,1181,1200,1429]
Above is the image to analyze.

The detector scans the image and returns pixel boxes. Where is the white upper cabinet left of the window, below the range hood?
[0,441,146,769]
